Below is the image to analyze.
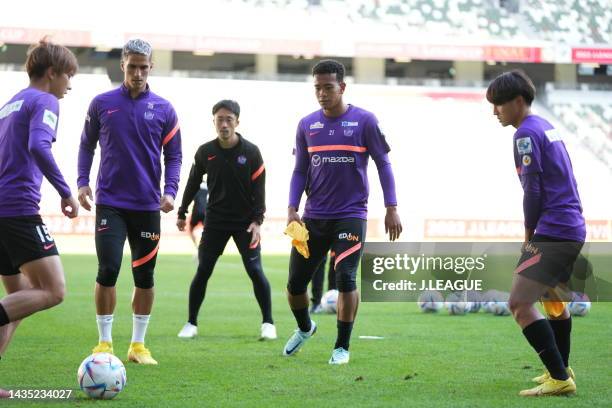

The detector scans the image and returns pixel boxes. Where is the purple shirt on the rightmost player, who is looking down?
[514,115,586,242]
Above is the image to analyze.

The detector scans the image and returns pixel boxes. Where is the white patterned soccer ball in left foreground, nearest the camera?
[77,353,127,399]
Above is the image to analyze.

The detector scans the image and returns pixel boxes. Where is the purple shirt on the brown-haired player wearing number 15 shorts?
[0,88,71,217]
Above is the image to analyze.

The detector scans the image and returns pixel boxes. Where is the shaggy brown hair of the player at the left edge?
[25,38,79,79]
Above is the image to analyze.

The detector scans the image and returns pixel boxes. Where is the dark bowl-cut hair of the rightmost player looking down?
[487,69,535,106]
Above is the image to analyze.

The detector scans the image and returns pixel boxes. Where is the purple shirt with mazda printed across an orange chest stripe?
[289,105,397,219]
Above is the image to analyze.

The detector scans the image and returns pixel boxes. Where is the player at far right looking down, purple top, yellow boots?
[486,70,586,396]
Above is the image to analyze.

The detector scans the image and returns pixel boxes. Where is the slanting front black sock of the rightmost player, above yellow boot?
[523,319,568,380]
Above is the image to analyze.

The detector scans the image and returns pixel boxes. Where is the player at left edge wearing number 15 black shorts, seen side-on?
[0,40,79,398]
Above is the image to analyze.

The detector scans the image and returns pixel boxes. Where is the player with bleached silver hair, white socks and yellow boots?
[78,39,182,364]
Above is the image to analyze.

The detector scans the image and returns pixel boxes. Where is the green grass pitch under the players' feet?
[0,255,612,408]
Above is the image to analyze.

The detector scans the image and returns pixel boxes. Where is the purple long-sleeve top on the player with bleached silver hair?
[77,85,182,211]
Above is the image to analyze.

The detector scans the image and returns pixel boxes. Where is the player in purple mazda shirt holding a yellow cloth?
[283,60,402,364]
